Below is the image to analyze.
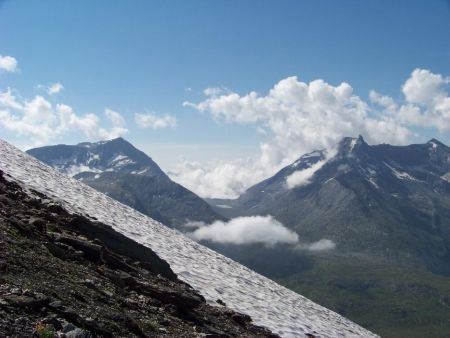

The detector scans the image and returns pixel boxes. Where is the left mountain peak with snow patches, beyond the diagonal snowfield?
[28,138,224,229]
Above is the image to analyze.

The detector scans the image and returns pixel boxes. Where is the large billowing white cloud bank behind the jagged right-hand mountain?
[171,69,450,198]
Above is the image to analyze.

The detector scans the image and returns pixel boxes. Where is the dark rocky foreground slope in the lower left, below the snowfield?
[0,171,278,338]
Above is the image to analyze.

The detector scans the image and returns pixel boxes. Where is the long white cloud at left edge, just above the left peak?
[0,88,127,146]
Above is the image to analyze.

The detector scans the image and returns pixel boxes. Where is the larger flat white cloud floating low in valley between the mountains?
[189,216,298,246]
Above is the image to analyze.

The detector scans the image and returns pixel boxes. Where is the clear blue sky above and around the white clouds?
[0,0,450,197]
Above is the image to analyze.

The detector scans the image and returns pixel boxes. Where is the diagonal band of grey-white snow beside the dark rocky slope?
[0,140,376,338]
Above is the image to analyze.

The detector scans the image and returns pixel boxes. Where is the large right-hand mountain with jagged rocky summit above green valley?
[221,137,450,275]
